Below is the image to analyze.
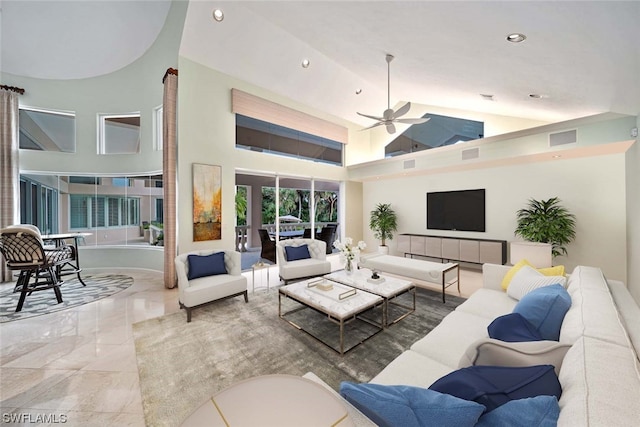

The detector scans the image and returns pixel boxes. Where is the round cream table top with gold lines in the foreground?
[182,374,353,427]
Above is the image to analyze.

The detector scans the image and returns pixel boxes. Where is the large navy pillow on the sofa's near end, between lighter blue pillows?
[429,365,562,412]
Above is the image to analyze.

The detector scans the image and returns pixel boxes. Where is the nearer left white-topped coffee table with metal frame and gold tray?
[278,278,384,355]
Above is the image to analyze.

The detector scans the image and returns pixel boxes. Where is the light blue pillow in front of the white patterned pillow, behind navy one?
[513,285,571,341]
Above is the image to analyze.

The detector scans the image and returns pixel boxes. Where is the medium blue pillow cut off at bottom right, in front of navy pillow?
[476,396,560,427]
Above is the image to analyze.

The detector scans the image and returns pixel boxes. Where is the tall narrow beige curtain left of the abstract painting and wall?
[162,68,178,288]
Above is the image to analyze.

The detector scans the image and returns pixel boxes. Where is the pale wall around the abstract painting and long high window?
[177,57,360,253]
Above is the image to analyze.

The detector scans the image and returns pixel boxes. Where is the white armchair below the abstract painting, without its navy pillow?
[175,250,249,323]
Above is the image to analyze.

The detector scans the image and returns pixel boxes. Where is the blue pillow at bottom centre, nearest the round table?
[340,382,485,427]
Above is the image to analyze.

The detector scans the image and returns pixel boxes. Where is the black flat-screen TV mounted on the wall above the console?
[427,189,485,231]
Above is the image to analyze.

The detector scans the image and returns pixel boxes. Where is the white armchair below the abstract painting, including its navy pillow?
[175,250,249,322]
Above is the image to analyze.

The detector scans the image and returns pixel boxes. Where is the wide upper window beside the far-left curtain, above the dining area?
[18,107,76,153]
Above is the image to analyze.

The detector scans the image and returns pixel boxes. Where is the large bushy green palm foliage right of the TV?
[514,197,576,257]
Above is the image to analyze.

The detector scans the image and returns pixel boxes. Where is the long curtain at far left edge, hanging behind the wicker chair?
[0,87,24,282]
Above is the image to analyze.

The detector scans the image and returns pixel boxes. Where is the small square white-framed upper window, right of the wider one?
[98,112,140,154]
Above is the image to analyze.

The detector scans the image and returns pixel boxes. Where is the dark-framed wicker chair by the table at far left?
[0,225,74,312]
